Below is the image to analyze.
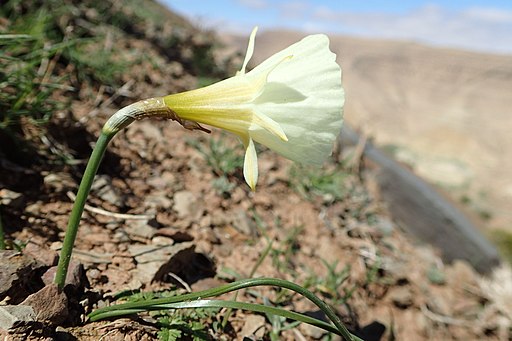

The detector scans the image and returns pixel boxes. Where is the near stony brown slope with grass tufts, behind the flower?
[0,0,512,341]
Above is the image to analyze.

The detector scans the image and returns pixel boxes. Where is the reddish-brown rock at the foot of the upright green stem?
[21,283,68,325]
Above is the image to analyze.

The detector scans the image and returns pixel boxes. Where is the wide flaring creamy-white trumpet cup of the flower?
[247,35,344,164]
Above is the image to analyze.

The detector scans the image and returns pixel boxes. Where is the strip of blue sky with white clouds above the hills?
[159,0,512,54]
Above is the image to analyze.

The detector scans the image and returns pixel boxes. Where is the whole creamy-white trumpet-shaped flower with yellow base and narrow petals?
[163,29,345,190]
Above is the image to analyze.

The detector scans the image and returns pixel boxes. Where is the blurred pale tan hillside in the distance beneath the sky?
[228,31,512,236]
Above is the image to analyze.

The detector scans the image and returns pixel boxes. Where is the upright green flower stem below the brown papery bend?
[55,132,115,289]
